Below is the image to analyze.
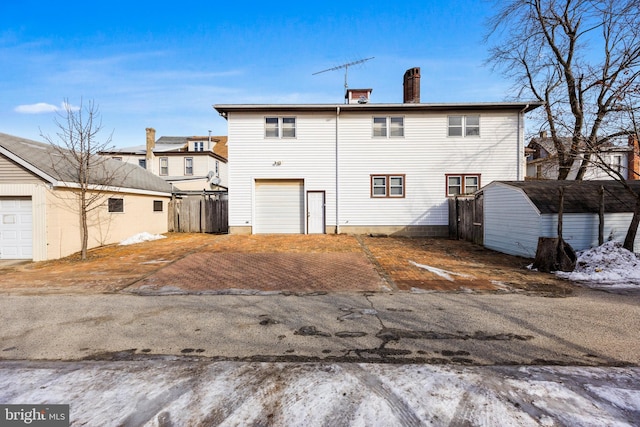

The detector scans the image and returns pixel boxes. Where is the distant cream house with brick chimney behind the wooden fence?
[101,128,228,194]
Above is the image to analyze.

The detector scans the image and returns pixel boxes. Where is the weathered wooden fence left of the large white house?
[169,197,229,233]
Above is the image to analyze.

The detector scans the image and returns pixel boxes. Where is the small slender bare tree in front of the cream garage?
[41,100,126,260]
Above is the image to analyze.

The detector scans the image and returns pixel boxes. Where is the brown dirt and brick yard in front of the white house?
[0,233,572,296]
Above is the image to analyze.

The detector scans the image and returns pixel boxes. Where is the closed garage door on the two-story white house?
[254,179,304,234]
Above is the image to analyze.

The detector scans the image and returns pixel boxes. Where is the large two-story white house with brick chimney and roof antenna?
[214,68,541,236]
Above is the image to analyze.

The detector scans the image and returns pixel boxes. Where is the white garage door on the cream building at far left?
[0,197,33,259]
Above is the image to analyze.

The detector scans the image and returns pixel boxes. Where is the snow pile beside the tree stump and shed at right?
[556,241,640,288]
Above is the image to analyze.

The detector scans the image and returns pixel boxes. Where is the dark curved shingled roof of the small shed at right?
[490,180,640,214]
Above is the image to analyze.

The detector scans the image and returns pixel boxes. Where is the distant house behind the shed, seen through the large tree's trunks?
[525,131,640,180]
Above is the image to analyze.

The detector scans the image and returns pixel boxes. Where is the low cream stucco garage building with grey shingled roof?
[0,133,171,261]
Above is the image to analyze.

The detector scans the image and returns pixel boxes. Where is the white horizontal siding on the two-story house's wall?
[227,108,524,232]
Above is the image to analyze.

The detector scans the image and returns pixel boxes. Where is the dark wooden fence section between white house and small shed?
[449,193,484,245]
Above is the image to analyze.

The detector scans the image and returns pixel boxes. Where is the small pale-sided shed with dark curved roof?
[481,180,640,258]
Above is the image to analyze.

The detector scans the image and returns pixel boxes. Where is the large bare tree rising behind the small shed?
[487,0,640,180]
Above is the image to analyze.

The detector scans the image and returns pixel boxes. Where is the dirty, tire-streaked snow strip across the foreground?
[0,360,640,426]
